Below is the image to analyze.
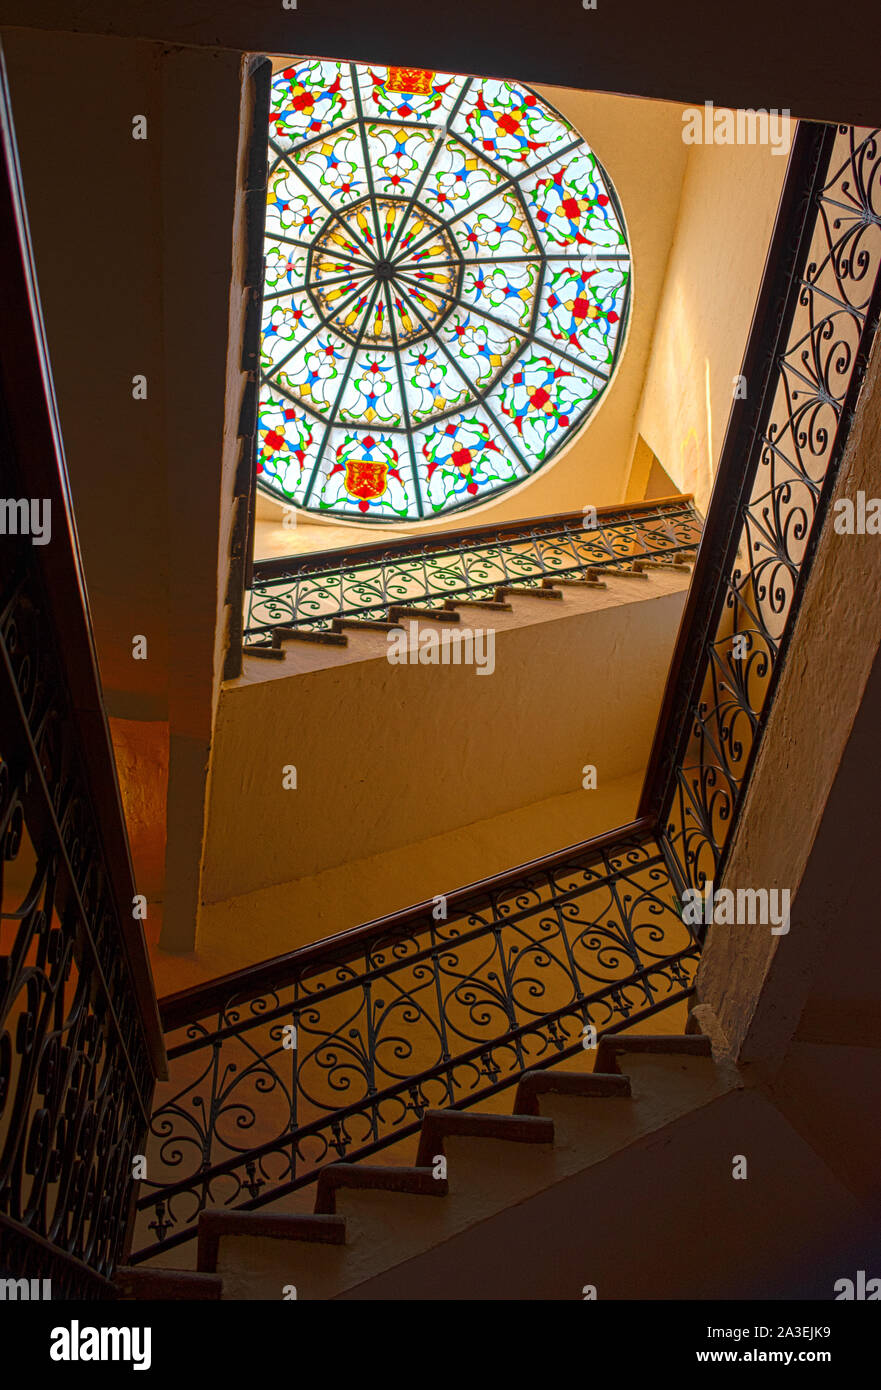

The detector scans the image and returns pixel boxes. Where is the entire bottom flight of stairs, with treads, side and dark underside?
[117,1034,866,1302]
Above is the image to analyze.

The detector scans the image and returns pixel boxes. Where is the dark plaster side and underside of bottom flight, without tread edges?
[138,1054,877,1302]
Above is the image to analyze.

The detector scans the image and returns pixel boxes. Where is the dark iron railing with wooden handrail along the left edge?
[0,51,165,1298]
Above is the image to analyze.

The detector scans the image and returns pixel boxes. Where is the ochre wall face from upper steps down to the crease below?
[203,571,686,902]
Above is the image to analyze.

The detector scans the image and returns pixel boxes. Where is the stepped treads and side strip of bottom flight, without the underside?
[117,1034,741,1300]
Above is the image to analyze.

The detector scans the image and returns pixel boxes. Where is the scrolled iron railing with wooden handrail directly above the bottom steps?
[136,826,698,1258]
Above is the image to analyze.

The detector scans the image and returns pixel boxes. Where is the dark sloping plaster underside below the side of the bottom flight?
[334,1078,873,1302]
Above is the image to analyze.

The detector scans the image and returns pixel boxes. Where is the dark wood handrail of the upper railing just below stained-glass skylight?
[252,492,695,582]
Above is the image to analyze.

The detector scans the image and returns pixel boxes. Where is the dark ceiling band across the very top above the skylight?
[0,0,881,125]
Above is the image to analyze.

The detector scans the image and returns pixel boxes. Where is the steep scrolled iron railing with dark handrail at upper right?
[641,124,881,888]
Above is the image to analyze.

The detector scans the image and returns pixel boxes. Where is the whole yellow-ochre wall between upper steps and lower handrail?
[137,573,686,973]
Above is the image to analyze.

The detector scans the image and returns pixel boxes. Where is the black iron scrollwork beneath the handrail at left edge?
[0,571,153,1297]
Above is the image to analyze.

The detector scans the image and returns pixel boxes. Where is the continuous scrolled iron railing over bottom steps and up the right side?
[128,124,881,1259]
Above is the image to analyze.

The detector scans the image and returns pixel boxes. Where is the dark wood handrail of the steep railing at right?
[638,121,837,817]
